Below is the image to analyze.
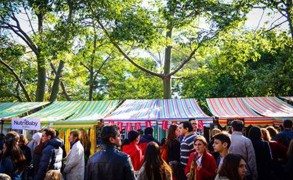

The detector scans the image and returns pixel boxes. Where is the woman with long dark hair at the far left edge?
[0,131,26,179]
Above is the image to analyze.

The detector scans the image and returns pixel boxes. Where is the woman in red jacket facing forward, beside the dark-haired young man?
[185,136,217,180]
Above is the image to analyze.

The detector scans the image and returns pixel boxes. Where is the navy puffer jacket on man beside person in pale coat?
[34,138,63,180]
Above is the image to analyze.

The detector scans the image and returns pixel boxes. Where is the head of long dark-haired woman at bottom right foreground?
[218,154,247,180]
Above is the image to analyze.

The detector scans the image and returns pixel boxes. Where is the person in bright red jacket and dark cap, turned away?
[122,130,143,171]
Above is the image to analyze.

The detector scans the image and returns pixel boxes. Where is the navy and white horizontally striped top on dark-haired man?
[180,133,196,166]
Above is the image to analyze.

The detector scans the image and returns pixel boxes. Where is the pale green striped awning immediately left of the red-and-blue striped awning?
[56,100,120,124]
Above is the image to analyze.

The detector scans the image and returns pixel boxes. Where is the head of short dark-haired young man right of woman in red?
[213,133,231,153]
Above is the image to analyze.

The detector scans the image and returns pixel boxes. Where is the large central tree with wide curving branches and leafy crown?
[84,0,248,98]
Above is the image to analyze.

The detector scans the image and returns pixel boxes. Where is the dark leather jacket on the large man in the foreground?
[85,145,135,180]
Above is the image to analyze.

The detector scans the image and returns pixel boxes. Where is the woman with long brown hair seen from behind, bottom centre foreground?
[137,141,172,180]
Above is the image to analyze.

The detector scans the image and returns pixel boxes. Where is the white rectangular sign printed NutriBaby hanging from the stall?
[11,118,41,130]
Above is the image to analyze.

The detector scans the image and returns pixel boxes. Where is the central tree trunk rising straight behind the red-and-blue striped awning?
[163,25,173,99]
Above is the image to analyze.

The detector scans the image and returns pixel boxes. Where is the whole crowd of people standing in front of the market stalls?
[0,119,293,180]
